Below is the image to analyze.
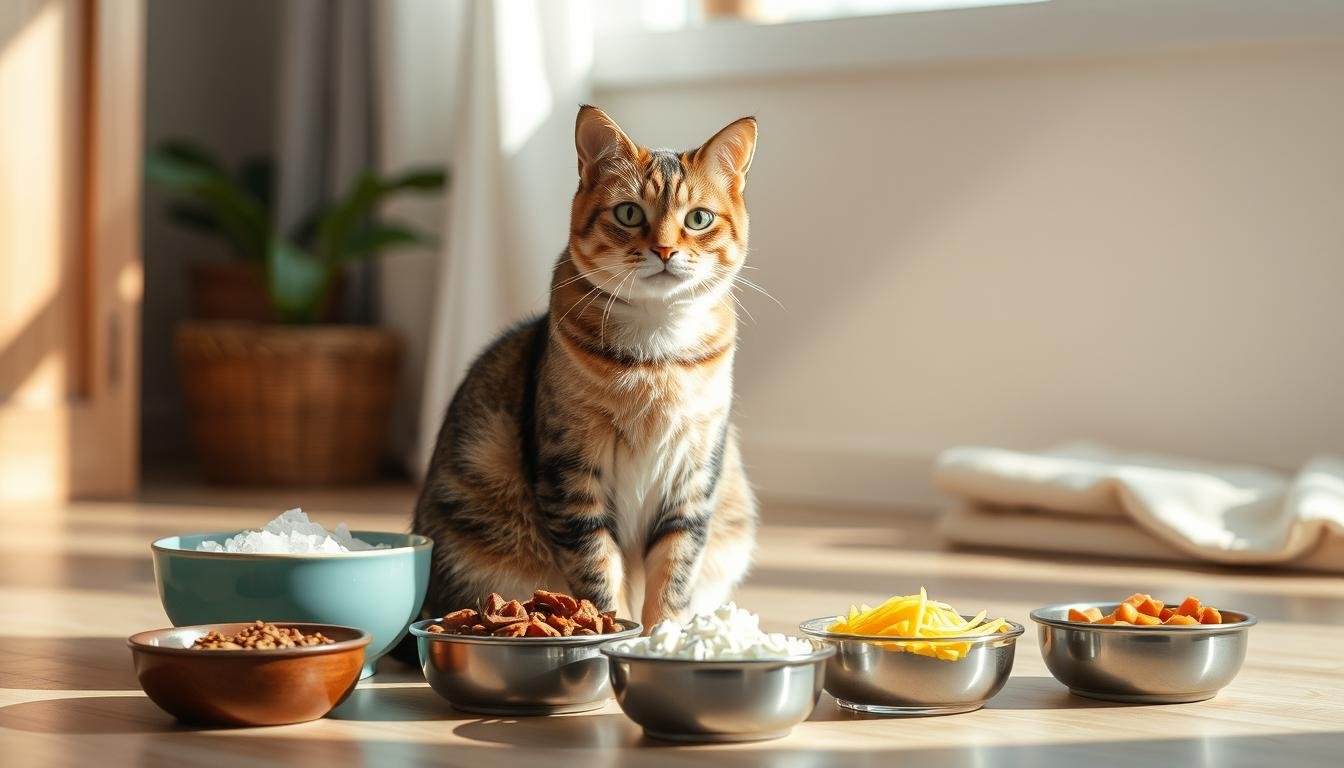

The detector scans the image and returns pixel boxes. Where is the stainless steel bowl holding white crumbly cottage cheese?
[602,642,835,741]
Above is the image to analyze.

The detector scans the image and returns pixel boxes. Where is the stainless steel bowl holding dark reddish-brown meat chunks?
[410,619,640,716]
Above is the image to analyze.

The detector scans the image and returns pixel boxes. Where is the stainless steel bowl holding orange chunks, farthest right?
[1031,603,1255,703]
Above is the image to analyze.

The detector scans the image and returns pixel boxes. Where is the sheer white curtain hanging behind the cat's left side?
[375,0,593,475]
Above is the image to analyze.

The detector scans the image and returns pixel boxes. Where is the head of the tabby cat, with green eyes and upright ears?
[570,106,757,301]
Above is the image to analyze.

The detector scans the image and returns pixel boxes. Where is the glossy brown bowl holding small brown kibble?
[126,621,372,725]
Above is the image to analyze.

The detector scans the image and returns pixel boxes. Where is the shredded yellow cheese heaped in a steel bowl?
[831,586,1008,662]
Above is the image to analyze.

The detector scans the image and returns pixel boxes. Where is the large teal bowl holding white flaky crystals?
[151,531,433,678]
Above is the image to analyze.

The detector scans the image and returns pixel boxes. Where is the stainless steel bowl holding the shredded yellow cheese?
[798,616,1024,717]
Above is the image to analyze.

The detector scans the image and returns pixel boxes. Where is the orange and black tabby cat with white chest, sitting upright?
[414,106,757,627]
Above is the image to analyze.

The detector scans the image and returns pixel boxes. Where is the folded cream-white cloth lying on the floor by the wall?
[934,443,1344,570]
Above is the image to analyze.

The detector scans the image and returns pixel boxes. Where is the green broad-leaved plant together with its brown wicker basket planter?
[146,141,445,484]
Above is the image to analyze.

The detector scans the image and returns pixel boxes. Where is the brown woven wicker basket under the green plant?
[176,321,402,486]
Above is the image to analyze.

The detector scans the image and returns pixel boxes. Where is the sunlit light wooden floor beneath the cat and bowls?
[0,487,1344,768]
